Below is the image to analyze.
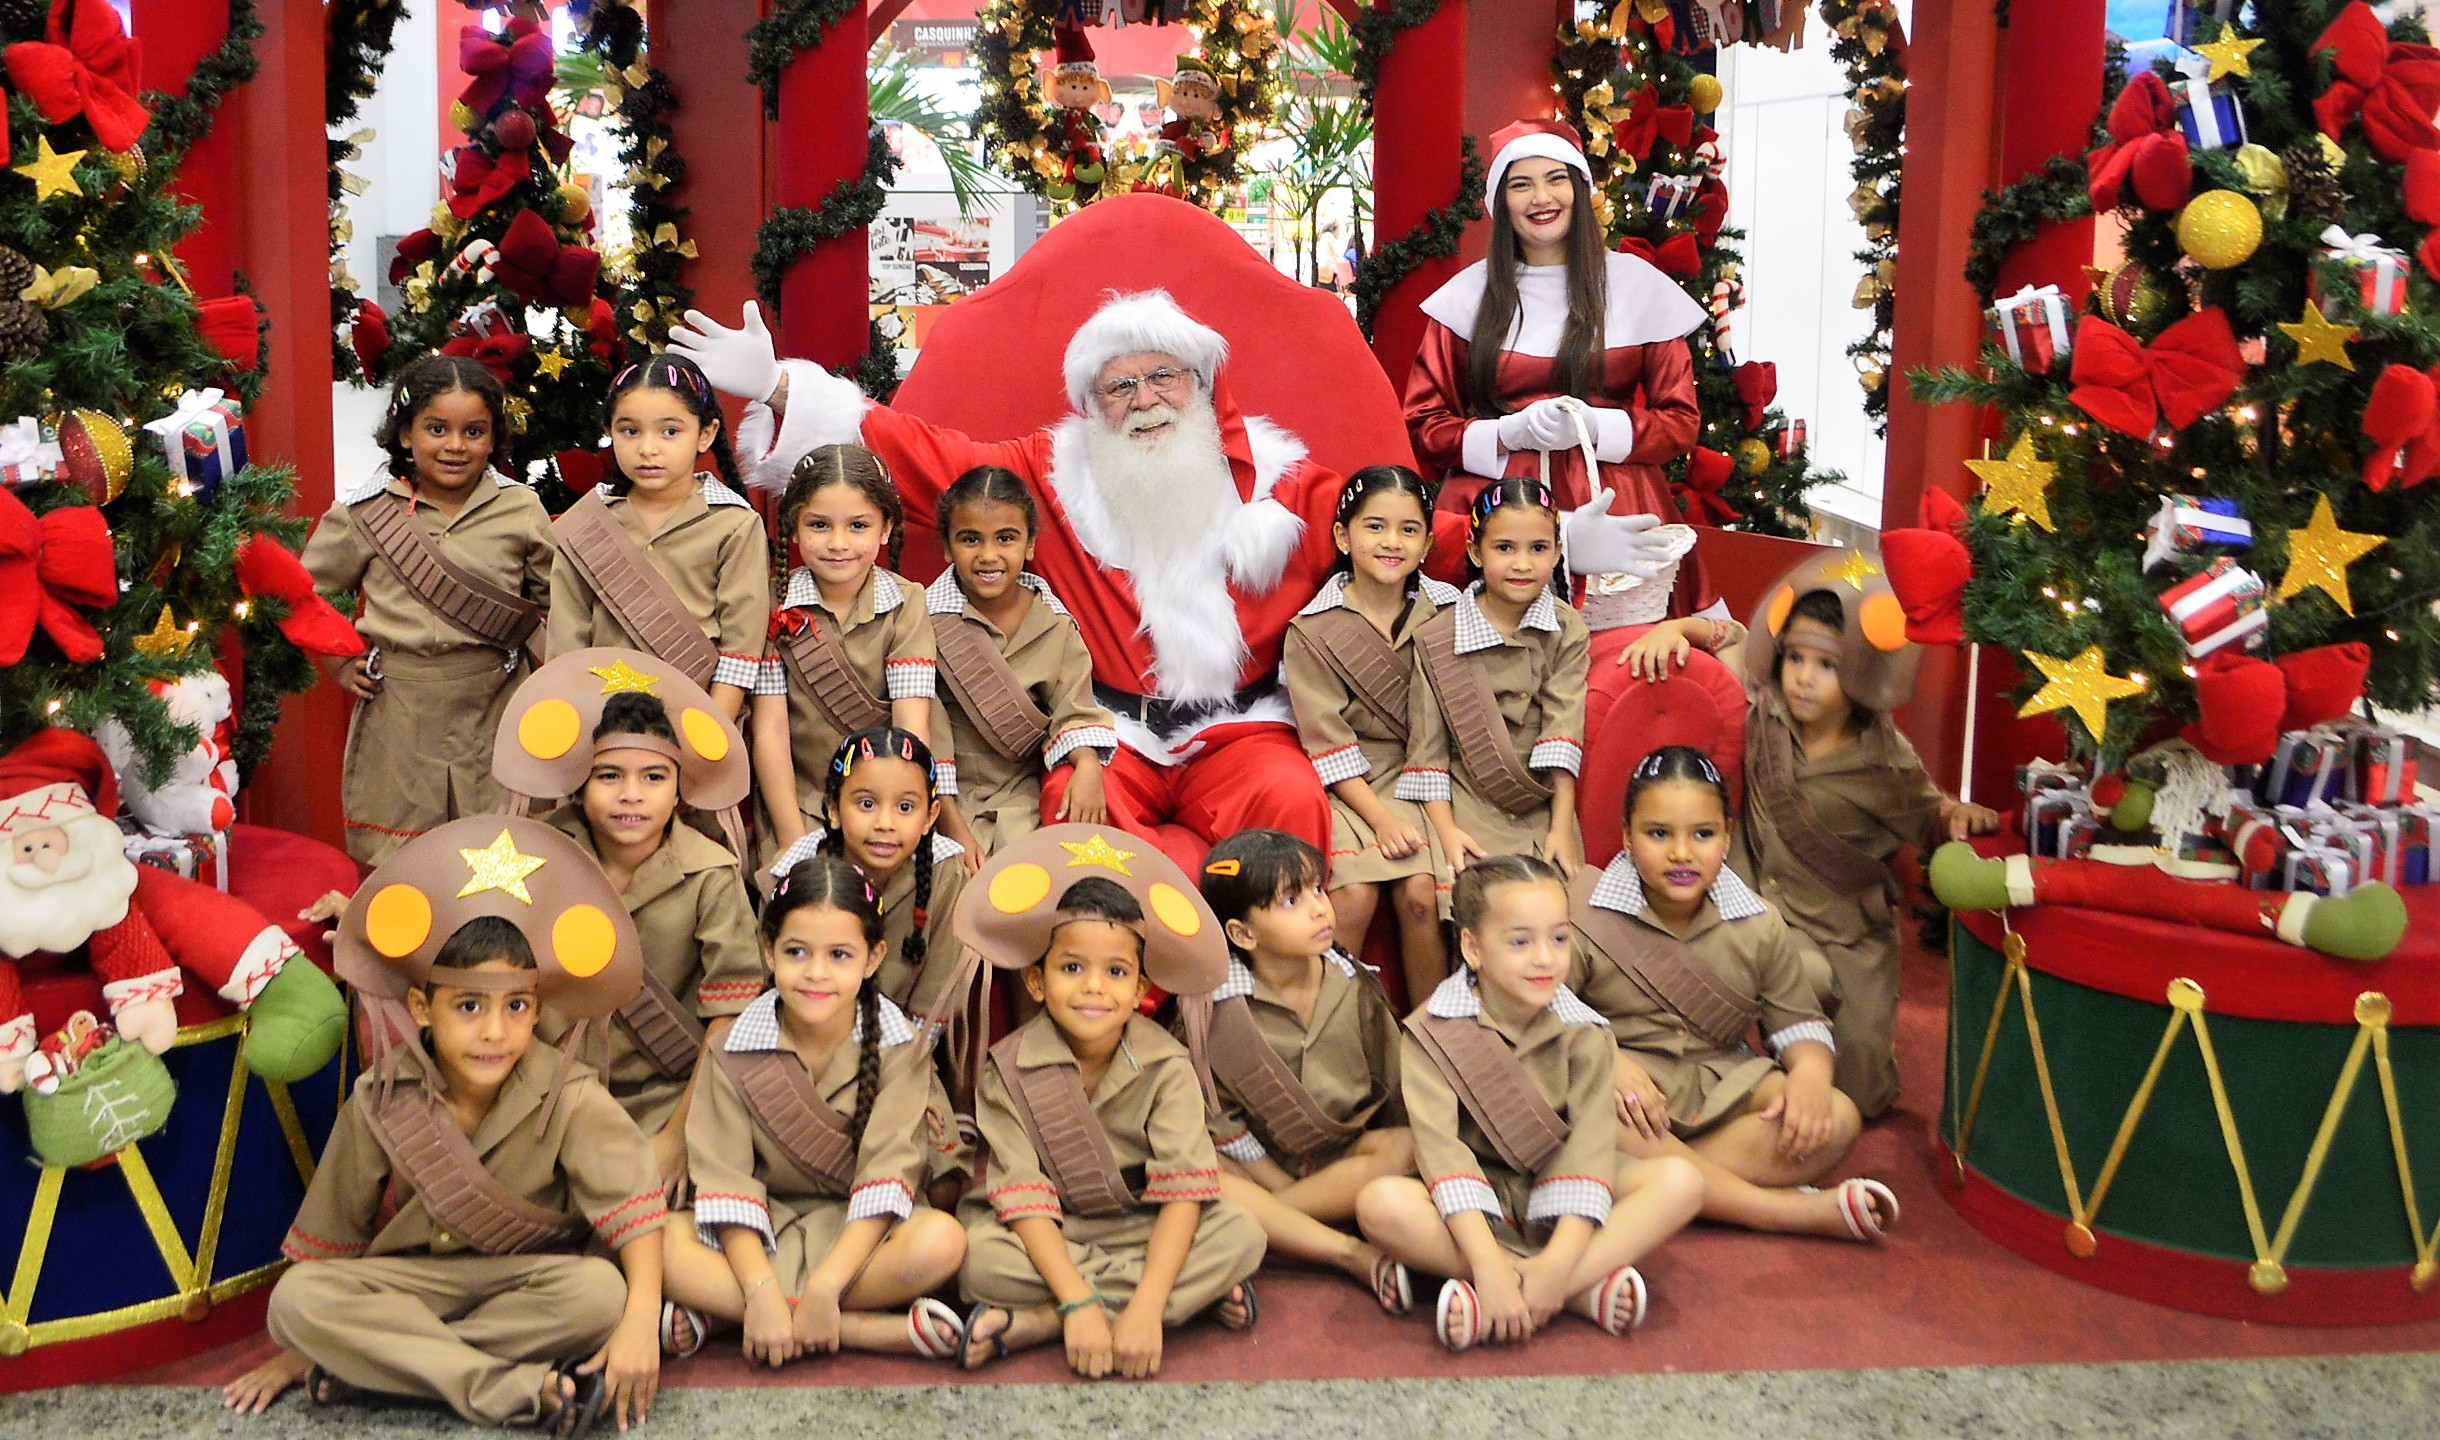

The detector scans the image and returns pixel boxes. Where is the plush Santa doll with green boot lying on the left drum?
[0,727,346,1091]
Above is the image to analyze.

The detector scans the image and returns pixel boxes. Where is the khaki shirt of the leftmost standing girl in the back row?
[303,473,554,657]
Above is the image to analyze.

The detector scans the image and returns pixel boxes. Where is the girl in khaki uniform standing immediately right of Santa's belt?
[1279,466,1457,996]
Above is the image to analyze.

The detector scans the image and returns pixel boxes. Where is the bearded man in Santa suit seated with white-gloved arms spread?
[671,290,1657,866]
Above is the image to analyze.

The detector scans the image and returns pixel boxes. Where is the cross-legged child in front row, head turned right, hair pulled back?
[1357,854,1703,1350]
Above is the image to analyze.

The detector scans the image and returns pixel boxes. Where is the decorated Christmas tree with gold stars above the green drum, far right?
[1893,0,2440,764]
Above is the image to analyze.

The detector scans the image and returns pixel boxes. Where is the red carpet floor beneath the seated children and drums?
[114,917,2440,1386]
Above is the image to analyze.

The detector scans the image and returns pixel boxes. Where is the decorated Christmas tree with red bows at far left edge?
[0,0,346,783]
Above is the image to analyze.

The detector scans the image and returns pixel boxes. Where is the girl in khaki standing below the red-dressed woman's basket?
[1396,481,1591,893]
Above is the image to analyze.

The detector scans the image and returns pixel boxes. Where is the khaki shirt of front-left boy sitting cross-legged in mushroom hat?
[281,1045,669,1259]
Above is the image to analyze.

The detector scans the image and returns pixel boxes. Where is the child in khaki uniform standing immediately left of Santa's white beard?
[925,466,1118,864]
